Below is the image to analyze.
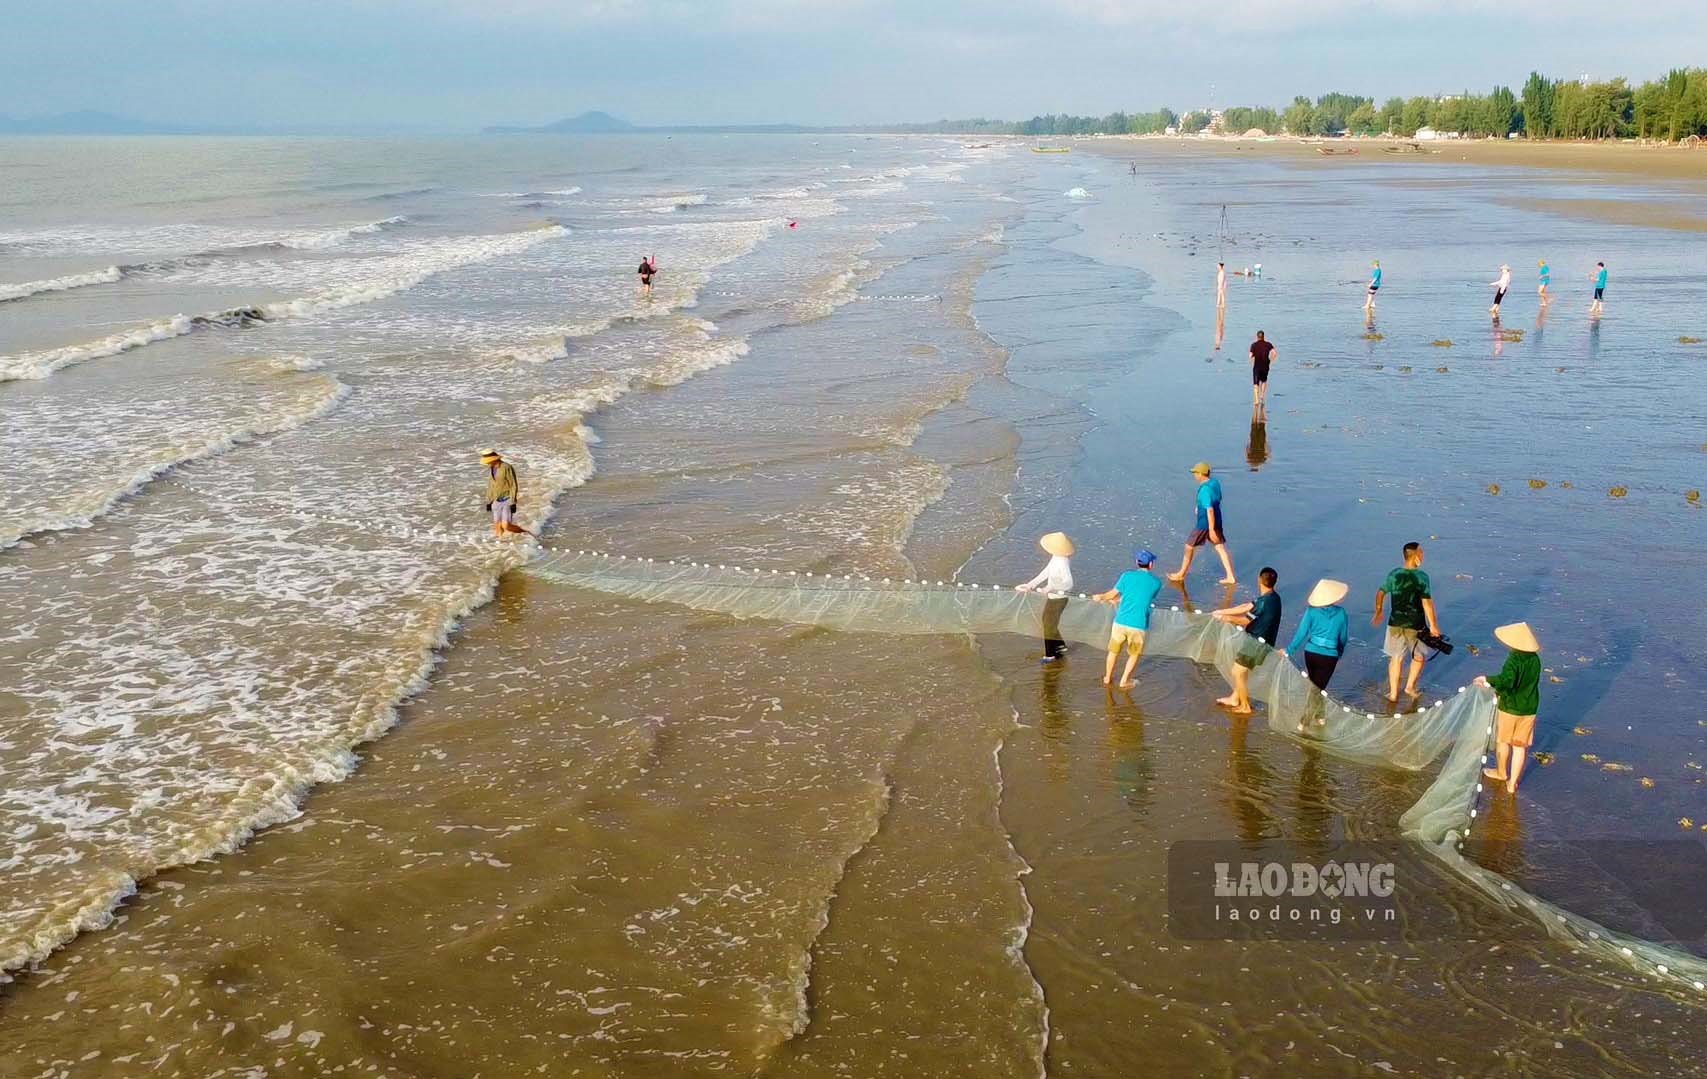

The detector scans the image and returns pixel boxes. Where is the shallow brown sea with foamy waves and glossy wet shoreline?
[0,138,1707,1076]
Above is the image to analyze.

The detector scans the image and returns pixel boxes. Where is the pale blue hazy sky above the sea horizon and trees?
[0,0,1707,130]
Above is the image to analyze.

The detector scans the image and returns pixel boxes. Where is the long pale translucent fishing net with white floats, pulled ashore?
[527,551,1707,990]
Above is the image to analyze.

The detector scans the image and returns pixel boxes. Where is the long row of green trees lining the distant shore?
[905,68,1707,142]
